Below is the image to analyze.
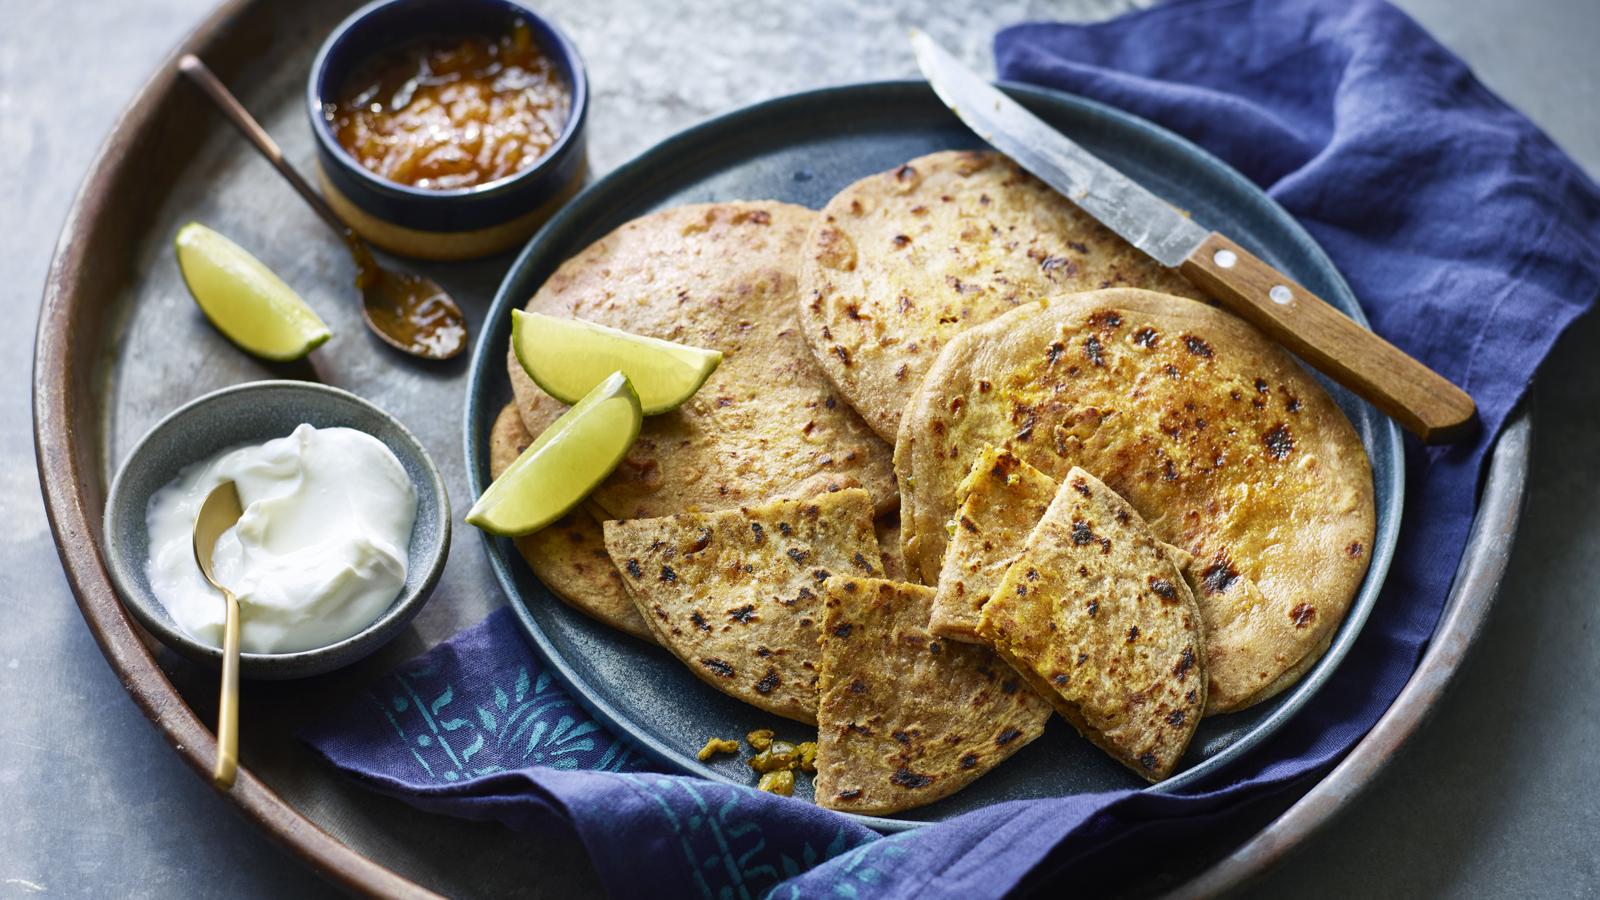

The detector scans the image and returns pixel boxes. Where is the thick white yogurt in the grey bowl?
[146,424,416,653]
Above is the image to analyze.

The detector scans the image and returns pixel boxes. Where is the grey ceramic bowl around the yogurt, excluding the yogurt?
[104,374,450,679]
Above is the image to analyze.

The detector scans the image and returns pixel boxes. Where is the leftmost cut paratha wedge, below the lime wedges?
[605,488,883,724]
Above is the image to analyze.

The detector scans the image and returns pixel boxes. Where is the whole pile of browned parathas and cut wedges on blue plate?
[491,152,1374,814]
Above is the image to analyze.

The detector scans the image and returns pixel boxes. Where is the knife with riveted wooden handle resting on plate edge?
[910,29,1477,444]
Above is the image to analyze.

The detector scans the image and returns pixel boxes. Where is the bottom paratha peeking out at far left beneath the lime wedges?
[490,405,656,642]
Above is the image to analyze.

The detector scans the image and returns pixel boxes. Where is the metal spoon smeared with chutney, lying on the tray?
[178,53,467,359]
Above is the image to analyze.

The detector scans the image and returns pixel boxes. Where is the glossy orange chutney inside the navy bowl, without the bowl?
[323,19,571,191]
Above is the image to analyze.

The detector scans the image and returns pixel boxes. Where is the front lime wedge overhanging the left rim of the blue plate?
[467,372,645,536]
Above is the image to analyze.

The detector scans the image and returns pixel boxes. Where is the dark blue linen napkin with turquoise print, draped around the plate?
[304,0,1600,897]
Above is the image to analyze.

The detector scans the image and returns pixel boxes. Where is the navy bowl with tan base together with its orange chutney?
[307,0,589,259]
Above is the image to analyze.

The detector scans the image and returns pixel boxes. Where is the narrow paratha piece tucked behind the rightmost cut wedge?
[930,447,1056,642]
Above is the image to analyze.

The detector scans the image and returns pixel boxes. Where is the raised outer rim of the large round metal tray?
[32,0,1510,897]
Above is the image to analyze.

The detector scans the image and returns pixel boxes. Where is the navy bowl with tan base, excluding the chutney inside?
[306,0,589,259]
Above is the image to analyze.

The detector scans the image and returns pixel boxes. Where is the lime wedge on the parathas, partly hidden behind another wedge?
[510,309,722,416]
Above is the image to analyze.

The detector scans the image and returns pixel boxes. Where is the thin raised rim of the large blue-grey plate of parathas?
[462,78,1406,834]
